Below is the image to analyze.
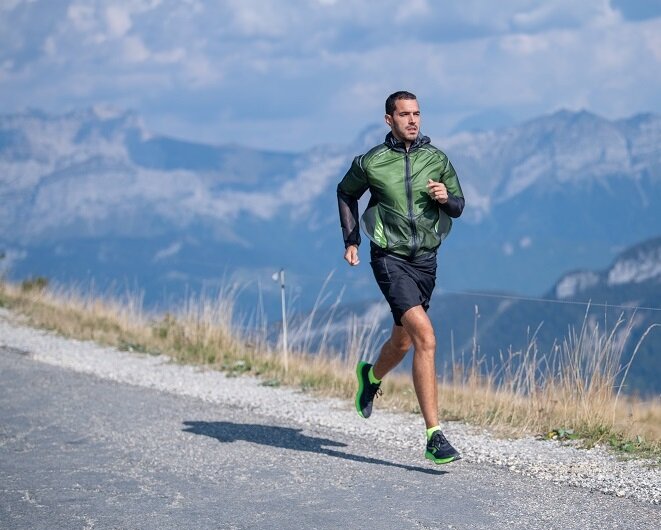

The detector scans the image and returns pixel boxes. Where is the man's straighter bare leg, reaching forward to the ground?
[402,306,438,429]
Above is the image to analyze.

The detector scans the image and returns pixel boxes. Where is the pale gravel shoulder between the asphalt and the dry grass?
[0,308,661,505]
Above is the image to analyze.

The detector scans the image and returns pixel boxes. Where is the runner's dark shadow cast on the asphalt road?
[182,421,447,475]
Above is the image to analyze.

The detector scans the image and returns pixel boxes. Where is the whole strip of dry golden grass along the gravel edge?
[0,282,661,458]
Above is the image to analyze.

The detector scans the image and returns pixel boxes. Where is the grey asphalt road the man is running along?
[0,348,661,529]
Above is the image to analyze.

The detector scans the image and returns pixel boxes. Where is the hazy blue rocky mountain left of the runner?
[0,104,348,308]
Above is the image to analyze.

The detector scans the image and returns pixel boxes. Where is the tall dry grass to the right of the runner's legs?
[440,307,661,446]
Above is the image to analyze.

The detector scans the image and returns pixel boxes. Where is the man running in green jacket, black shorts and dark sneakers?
[337,91,464,464]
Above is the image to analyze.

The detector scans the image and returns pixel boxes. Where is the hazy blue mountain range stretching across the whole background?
[0,106,661,390]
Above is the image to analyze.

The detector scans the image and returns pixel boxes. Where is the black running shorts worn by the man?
[370,245,436,326]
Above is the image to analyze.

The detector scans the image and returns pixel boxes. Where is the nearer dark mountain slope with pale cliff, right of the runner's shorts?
[431,237,661,394]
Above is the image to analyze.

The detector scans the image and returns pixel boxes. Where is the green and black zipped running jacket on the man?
[337,133,464,258]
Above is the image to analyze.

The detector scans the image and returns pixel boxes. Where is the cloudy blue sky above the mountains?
[0,0,661,151]
